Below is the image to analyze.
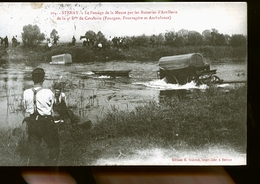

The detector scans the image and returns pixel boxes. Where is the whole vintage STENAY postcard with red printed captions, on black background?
[0,2,248,166]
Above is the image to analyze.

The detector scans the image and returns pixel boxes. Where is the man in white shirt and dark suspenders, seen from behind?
[23,68,60,166]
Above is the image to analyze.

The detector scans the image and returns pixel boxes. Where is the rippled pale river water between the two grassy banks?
[0,61,247,127]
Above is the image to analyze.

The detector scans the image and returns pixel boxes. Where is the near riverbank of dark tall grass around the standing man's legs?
[0,87,247,166]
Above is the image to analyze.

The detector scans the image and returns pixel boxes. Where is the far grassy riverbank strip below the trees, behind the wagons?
[1,44,247,66]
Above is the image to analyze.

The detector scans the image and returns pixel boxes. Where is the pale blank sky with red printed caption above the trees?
[0,2,247,41]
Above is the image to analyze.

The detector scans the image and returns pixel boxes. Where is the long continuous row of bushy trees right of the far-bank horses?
[101,29,247,48]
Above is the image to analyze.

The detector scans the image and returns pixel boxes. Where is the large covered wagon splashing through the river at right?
[158,53,222,85]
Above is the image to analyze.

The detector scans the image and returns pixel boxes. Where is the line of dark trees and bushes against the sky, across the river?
[22,24,247,48]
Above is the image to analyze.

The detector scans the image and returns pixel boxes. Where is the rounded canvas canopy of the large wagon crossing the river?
[159,53,208,70]
